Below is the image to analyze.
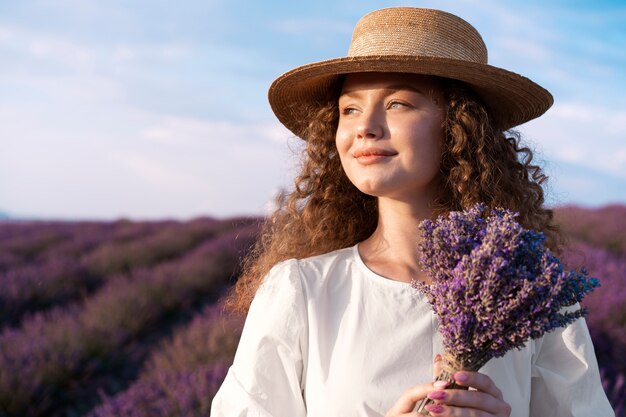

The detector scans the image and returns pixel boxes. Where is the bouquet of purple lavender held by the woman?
[414,204,599,412]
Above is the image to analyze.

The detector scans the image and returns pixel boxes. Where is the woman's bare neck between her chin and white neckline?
[359,198,432,282]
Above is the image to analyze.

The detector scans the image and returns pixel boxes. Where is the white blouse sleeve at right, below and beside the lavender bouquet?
[530,308,615,417]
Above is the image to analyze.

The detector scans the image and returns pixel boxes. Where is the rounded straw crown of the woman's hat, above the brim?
[348,7,487,64]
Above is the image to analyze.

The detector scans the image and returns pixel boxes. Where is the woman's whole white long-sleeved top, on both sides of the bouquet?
[211,246,614,417]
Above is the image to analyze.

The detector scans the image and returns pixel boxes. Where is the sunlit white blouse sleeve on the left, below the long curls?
[211,260,308,417]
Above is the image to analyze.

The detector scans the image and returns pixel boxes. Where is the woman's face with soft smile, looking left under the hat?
[336,73,443,204]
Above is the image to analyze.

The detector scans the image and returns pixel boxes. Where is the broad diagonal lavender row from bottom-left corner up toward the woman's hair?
[0,219,256,416]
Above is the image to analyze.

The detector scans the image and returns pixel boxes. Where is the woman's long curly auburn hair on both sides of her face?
[226,76,559,313]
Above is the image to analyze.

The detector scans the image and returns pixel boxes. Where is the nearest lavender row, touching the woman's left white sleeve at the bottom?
[89,305,243,417]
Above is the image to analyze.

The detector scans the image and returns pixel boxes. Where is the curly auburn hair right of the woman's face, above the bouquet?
[428,80,562,244]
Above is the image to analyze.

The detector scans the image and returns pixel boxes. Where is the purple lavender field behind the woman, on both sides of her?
[0,206,626,417]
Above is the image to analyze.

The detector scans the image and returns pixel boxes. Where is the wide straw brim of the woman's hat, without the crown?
[268,55,553,137]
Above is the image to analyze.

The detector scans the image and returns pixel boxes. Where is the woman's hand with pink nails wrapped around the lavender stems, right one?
[426,371,511,417]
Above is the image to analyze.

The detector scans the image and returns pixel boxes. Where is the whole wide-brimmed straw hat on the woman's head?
[269,7,553,136]
